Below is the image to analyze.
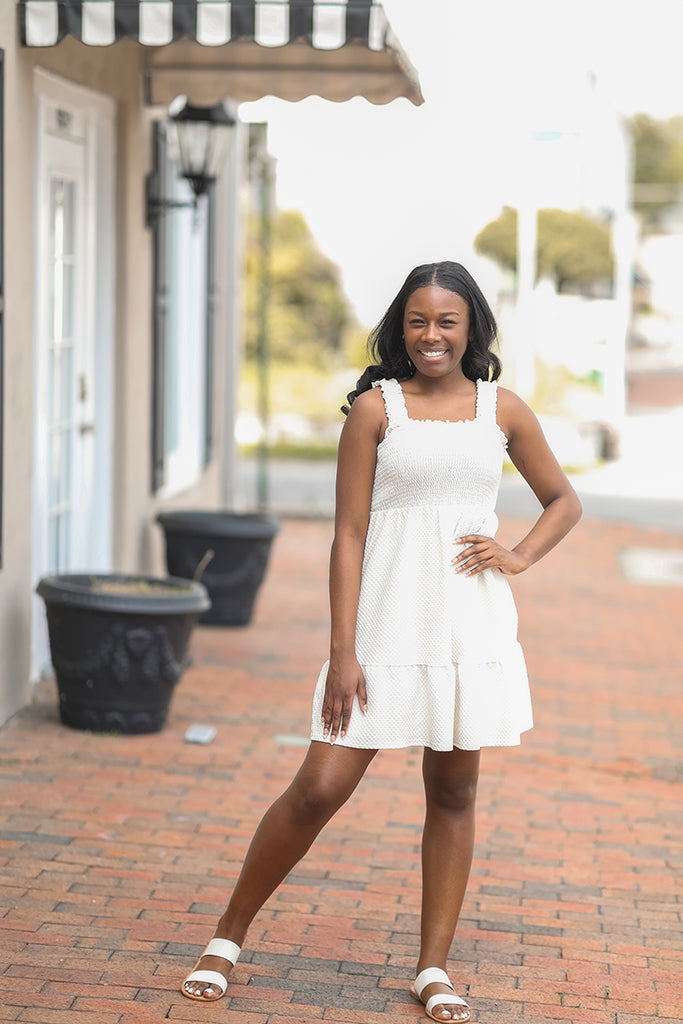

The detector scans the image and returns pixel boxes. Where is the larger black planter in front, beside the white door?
[37,573,210,733]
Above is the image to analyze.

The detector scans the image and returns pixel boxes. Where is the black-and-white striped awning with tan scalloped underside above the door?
[17,0,423,104]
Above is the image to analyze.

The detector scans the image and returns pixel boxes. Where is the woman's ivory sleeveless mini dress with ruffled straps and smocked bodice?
[311,380,533,751]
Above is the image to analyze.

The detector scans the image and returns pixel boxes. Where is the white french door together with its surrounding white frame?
[32,78,114,676]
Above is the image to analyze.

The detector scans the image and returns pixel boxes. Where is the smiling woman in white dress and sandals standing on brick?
[181,262,581,1021]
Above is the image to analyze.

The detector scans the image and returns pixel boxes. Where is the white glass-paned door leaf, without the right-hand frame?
[32,97,91,678]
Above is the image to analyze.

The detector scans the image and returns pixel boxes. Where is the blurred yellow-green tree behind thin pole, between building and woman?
[244,210,355,369]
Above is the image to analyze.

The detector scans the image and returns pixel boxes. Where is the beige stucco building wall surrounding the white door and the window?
[0,28,236,722]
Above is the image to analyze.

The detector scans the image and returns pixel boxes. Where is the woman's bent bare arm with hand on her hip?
[454,388,582,575]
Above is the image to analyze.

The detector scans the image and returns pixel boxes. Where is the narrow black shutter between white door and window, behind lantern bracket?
[147,121,168,494]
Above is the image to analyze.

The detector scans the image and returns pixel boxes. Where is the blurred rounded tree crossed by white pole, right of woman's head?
[474,206,613,292]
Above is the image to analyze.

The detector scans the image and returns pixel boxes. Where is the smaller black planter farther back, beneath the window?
[157,511,280,626]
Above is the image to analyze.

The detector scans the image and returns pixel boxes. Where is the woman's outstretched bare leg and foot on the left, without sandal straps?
[185,741,377,1001]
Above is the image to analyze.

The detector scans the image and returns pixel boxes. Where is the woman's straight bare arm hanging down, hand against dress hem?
[323,389,386,742]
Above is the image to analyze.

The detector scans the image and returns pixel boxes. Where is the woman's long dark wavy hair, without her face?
[342,260,502,413]
